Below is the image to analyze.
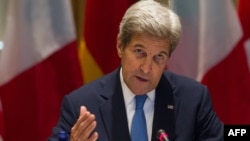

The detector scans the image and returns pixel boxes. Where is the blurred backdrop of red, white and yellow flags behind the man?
[0,0,250,141]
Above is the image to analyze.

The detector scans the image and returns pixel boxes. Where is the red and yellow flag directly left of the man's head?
[79,0,136,83]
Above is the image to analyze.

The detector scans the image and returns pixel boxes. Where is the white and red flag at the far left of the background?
[0,0,82,141]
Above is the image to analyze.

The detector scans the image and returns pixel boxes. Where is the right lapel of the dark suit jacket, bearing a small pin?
[152,76,176,141]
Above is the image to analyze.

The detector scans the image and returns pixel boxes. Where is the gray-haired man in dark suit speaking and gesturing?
[49,0,224,141]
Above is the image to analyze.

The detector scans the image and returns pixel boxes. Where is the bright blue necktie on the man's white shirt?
[131,95,148,141]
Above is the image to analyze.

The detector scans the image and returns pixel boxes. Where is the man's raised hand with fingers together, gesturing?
[70,106,98,141]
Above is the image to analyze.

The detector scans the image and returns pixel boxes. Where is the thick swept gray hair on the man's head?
[118,0,181,55]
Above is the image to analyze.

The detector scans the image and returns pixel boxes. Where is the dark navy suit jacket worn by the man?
[49,69,224,141]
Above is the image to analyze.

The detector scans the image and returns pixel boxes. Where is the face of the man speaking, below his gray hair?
[117,34,170,94]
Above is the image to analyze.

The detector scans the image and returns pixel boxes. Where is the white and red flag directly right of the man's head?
[168,0,250,124]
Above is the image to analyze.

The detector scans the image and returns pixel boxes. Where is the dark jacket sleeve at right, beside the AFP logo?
[197,87,224,141]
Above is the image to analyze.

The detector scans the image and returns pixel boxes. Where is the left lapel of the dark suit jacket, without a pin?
[100,70,130,141]
